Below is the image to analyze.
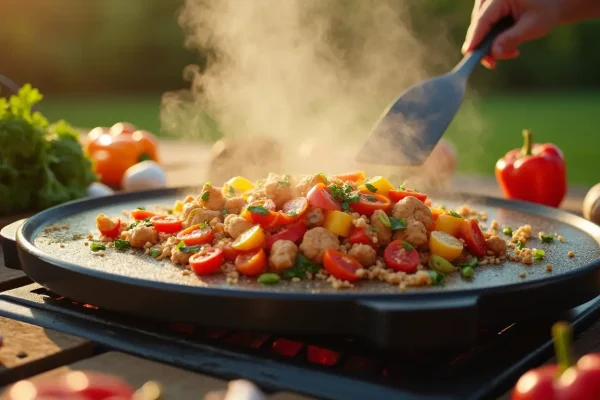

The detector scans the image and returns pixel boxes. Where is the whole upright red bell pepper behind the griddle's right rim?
[496,130,567,207]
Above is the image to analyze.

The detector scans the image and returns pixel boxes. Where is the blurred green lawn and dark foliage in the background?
[0,0,600,184]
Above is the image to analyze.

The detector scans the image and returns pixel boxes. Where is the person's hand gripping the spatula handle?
[462,0,560,68]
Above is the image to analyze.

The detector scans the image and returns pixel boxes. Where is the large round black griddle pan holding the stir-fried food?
[1,189,600,349]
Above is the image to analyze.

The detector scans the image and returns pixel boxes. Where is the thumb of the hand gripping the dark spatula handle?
[491,13,544,59]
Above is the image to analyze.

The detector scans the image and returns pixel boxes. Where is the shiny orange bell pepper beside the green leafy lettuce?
[85,124,158,187]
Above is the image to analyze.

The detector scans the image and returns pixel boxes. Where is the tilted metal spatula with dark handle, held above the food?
[357,17,514,165]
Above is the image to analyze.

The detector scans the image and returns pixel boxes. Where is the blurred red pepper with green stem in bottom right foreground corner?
[511,322,600,400]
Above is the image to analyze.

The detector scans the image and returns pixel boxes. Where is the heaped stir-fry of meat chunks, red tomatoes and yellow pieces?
[91,172,507,288]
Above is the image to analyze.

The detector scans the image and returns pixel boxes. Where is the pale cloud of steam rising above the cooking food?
[161,0,482,189]
